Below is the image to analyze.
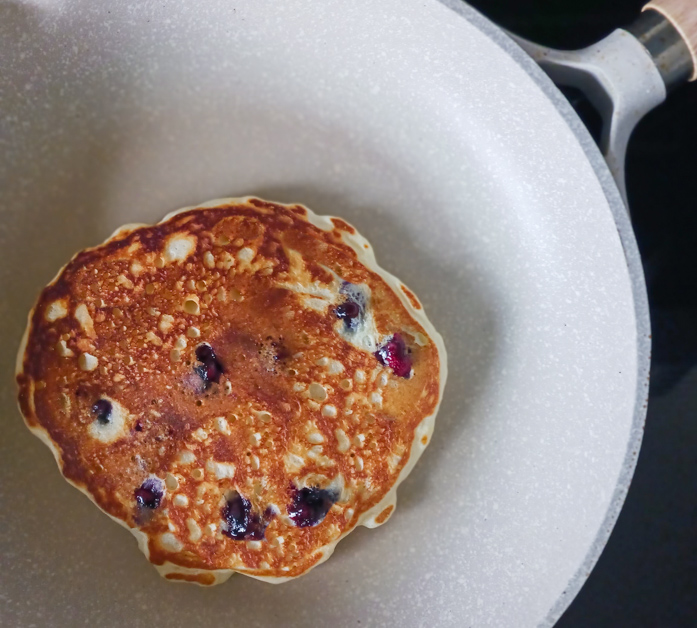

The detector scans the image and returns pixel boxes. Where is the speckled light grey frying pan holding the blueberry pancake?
[0,0,691,627]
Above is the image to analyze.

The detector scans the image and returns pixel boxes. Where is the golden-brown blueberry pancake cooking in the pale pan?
[17,198,446,585]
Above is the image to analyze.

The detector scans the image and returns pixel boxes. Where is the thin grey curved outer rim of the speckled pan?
[437,0,651,628]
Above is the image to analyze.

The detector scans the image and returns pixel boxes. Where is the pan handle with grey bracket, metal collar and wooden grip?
[511,6,697,210]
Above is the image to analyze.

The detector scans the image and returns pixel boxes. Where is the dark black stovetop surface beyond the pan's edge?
[468,0,697,628]
